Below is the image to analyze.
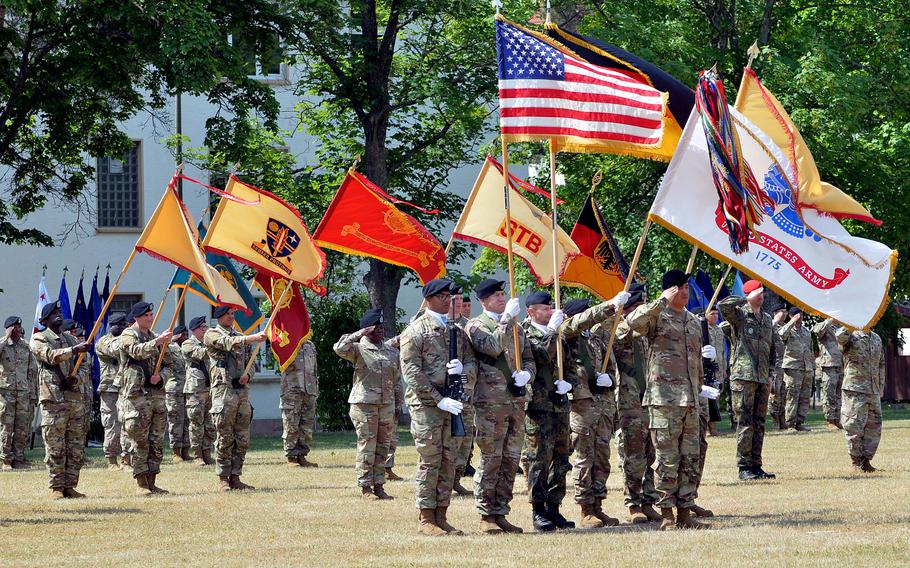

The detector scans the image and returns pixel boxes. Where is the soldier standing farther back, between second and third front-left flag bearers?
[180,316,215,466]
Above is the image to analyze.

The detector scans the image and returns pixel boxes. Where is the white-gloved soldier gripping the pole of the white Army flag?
[561,291,630,529]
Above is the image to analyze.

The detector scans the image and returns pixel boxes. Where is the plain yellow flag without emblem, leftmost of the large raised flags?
[136,184,247,311]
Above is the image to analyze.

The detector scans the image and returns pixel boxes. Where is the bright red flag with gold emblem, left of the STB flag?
[313,170,446,284]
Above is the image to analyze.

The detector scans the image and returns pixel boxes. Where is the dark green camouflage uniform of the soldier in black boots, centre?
[521,318,575,506]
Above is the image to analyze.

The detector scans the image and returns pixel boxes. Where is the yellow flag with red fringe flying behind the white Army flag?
[734,67,882,225]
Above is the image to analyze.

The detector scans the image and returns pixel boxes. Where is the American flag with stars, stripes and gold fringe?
[496,20,665,151]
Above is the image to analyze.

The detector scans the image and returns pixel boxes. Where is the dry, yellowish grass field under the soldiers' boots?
[0,407,910,567]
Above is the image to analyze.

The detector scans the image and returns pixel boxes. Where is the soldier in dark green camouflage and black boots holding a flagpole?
[521,292,575,532]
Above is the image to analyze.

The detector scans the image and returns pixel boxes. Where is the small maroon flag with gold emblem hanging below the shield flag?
[255,272,312,371]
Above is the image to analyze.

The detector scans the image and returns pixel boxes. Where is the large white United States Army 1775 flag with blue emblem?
[649,109,897,329]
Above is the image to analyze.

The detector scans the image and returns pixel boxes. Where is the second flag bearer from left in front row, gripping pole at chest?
[120,302,173,497]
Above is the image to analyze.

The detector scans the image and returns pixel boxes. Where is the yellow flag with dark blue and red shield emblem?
[203,176,325,284]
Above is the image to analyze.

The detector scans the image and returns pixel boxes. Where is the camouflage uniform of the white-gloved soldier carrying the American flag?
[462,312,536,516]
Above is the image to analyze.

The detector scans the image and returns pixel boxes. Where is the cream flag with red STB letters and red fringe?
[452,156,580,286]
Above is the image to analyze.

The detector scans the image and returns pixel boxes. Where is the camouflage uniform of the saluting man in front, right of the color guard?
[628,298,703,509]
